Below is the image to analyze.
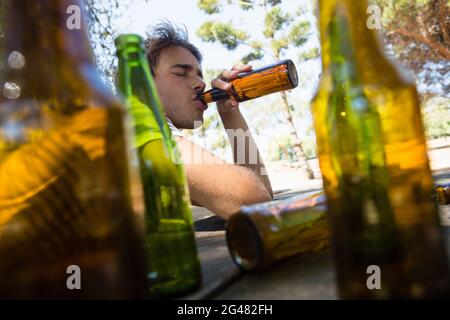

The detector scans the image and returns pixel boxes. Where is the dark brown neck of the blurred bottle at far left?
[4,0,94,98]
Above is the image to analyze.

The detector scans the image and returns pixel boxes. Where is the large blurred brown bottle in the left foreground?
[0,0,147,299]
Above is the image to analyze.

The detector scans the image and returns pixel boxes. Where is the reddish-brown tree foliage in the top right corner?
[375,0,450,100]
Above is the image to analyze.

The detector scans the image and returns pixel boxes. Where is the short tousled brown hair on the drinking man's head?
[145,21,202,75]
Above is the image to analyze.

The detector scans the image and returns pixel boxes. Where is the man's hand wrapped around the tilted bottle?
[211,64,252,113]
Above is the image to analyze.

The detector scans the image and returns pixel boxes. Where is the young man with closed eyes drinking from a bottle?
[146,23,272,219]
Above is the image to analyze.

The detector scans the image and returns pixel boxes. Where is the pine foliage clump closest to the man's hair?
[197,21,248,50]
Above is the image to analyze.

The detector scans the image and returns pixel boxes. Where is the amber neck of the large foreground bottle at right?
[319,0,383,71]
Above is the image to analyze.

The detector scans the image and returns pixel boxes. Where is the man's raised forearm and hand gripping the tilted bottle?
[211,65,273,197]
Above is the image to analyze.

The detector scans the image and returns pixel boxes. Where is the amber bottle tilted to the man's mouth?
[199,60,298,103]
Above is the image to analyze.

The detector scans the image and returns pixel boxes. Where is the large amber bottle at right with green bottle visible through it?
[312,0,449,299]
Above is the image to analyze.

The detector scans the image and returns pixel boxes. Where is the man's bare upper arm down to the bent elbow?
[176,137,271,219]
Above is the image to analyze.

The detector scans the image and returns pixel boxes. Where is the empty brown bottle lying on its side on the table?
[226,193,329,270]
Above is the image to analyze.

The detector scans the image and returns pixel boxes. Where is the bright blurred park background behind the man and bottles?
[0,0,450,190]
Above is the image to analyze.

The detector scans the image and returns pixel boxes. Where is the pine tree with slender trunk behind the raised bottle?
[197,0,318,179]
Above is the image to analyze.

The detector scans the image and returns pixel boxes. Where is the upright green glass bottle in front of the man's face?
[115,34,201,297]
